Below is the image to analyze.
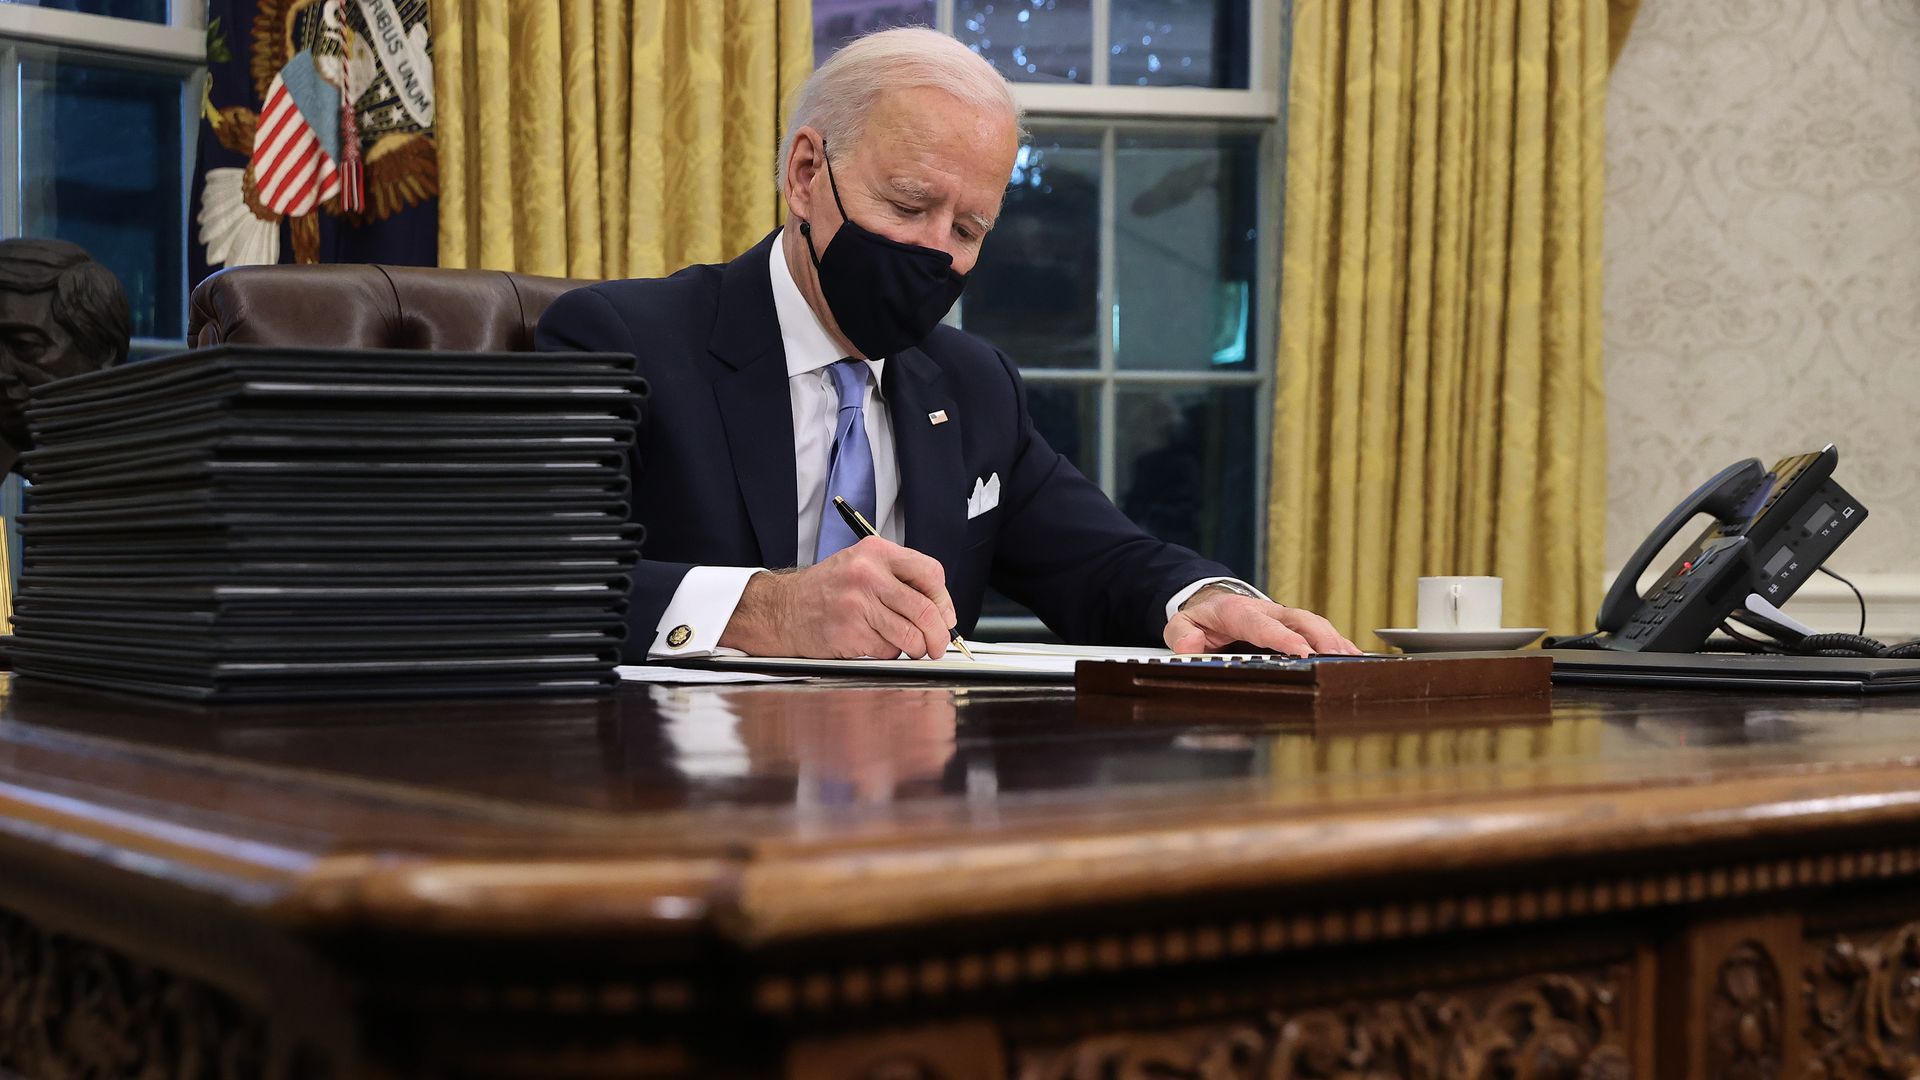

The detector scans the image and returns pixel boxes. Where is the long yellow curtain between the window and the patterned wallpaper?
[1267,0,1609,648]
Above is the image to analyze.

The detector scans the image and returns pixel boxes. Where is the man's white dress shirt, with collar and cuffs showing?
[647,224,1252,659]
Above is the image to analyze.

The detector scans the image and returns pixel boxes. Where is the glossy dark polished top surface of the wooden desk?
[11,682,1912,819]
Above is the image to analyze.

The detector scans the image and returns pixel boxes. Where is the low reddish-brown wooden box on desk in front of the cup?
[1073,651,1553,709]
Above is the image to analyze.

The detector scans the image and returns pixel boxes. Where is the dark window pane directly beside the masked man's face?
[960,133,1100,369]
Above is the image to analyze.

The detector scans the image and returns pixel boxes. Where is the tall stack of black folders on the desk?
[13,346,645,701]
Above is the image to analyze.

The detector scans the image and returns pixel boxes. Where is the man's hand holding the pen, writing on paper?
[720,536,956,659]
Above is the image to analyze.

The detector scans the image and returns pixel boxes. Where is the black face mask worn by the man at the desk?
[801,142,966,359]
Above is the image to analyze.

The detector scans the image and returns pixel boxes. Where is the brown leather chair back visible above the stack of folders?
[186,263,591,352]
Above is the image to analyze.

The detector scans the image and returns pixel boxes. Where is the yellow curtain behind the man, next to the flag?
[432,0,812,279]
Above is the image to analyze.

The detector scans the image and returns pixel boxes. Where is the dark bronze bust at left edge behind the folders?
[0,238,132,469]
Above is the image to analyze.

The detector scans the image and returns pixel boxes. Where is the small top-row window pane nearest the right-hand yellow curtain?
[1106,0,1252,90]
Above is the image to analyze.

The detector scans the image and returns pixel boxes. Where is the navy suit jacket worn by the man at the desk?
[534,233,1233,657]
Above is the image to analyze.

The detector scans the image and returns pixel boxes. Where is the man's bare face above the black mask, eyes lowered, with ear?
[795,86,1020,273]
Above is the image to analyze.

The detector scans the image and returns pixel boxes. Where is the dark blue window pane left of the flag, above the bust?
[21,58,186,338]
